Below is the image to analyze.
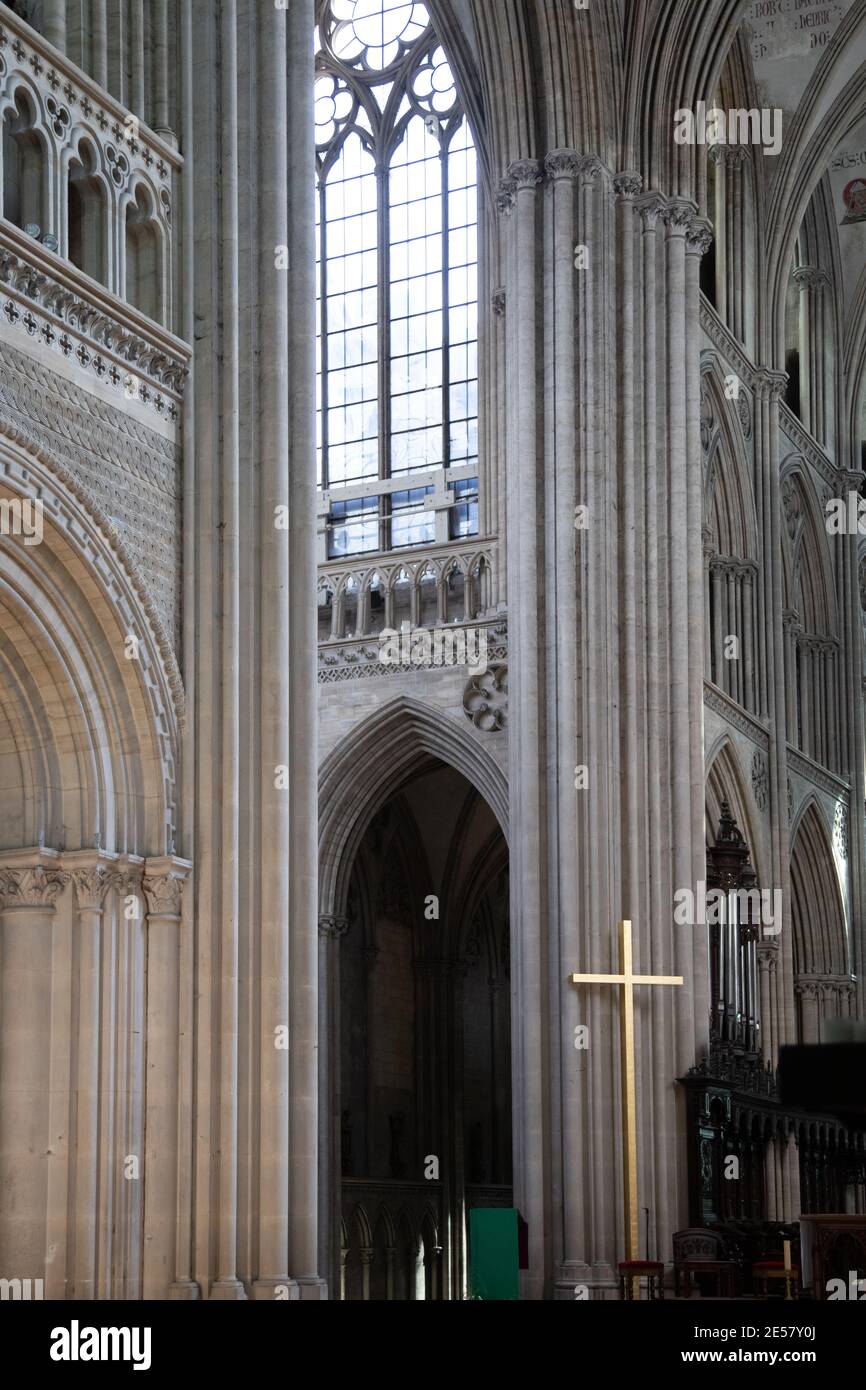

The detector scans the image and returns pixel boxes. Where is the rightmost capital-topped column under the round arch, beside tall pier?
[142,856,192,1298]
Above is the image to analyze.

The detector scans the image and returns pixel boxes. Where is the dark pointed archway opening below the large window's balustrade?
[320,712,513,1301]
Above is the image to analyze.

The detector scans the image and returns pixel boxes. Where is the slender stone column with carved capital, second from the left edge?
[64,853,120,1300]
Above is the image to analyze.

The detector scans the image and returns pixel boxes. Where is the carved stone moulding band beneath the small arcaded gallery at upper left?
[0,224,190,421]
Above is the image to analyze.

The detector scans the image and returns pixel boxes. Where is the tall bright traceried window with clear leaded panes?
[316,0,478,557]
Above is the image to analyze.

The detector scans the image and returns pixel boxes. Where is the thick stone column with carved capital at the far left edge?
[0,851,68,1279]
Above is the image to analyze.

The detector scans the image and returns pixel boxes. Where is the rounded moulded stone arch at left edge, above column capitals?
[0,427,182,855]
